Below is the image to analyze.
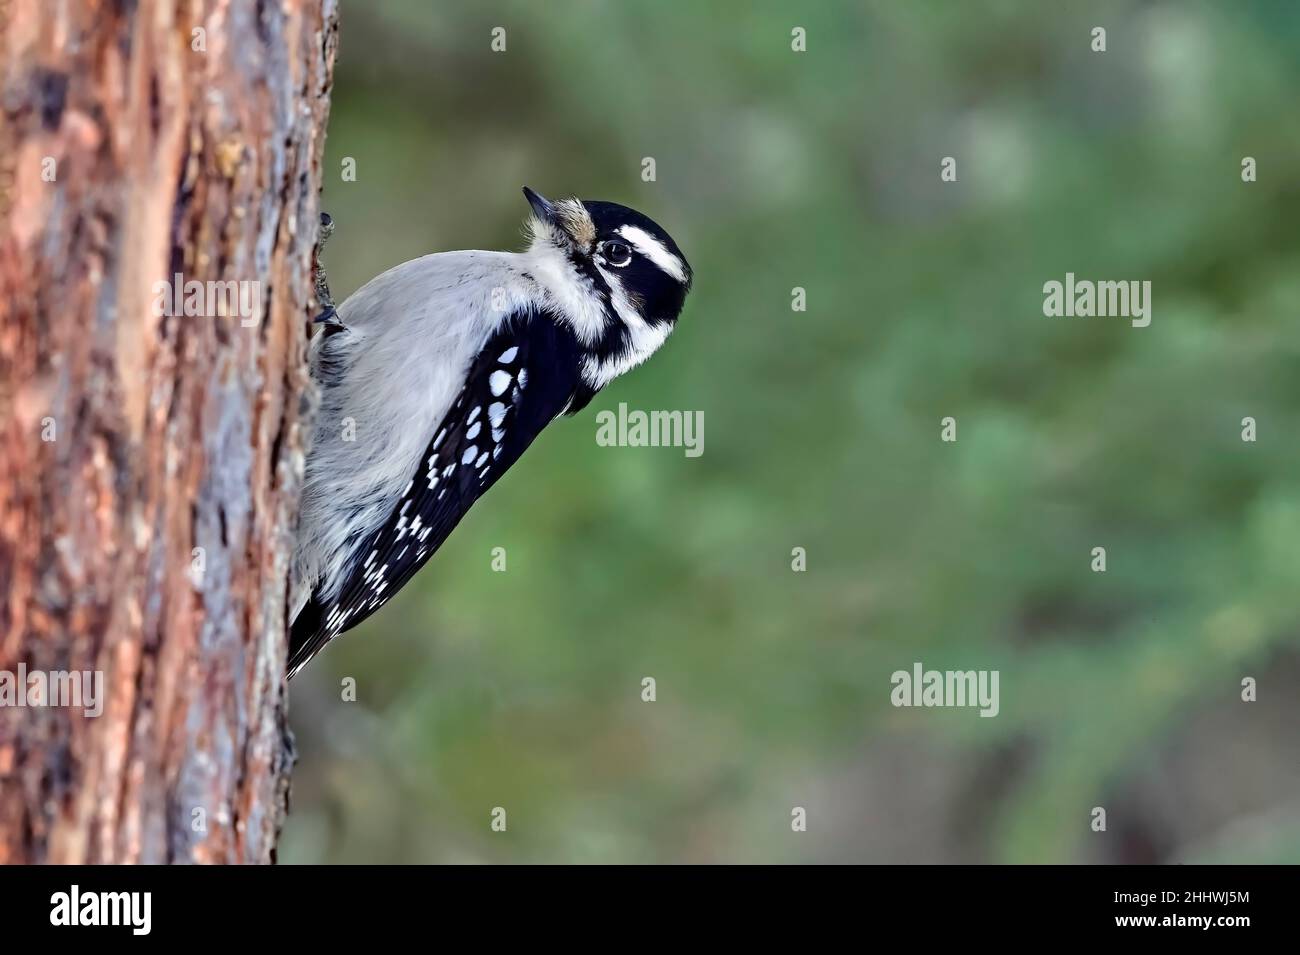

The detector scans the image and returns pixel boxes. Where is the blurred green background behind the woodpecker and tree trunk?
[282,0,1300,863]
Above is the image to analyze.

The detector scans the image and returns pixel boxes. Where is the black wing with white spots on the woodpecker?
[289,311,593,677]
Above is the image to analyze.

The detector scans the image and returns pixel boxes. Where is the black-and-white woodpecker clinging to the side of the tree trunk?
[289,187,692,677]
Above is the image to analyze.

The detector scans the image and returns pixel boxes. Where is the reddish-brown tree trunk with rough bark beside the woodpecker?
[0,0,337,863]
